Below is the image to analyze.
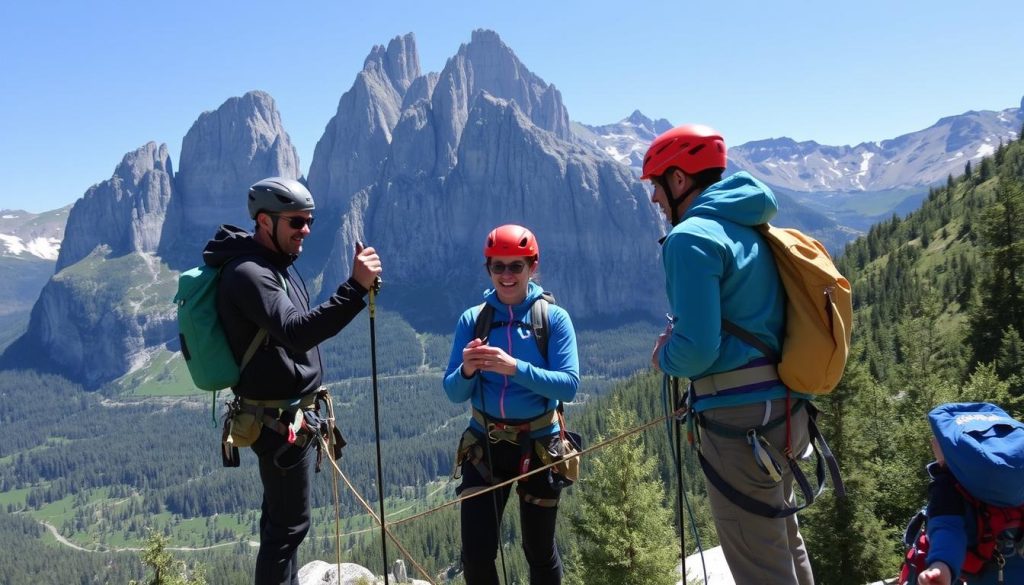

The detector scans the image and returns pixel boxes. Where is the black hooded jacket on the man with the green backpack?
[203,225,367,400]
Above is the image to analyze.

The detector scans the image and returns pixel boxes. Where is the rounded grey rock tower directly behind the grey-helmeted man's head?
[159,91,301,268]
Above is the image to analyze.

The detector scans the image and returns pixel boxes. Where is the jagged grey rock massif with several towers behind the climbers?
[3,31,1019,387]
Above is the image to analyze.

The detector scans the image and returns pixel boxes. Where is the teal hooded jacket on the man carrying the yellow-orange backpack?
[658,172,809,412]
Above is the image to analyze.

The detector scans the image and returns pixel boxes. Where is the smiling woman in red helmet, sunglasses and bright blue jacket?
[444,224,580,585]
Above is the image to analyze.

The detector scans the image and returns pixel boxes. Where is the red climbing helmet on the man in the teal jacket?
[640,124,726,180]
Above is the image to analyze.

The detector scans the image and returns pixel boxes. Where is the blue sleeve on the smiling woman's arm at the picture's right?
[513,305,580,403]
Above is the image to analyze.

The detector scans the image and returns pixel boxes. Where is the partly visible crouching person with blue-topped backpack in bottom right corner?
[900,403,1024,585]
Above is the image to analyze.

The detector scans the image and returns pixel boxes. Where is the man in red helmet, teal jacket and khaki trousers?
[642,125,814,585]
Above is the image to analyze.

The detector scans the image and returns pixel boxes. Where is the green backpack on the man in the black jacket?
[174,258,288,400]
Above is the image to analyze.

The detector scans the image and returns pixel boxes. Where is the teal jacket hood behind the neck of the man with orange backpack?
[683,171,778,225]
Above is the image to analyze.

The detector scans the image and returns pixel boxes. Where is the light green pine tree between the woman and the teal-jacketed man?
[571,402,679,585]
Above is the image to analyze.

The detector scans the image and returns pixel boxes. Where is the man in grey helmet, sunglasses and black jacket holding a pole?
[203,177,381,585]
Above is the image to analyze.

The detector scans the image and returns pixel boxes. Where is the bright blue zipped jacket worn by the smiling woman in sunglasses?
[444,282,580,436]
